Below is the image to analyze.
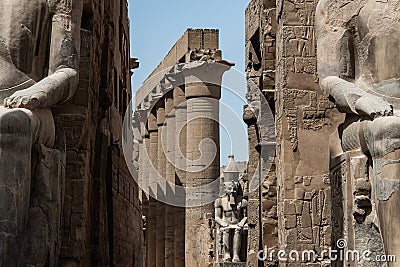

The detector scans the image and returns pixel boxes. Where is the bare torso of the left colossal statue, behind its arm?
[0,0,51,100]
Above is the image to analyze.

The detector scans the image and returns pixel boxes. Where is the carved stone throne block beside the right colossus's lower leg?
[330,150,386,267]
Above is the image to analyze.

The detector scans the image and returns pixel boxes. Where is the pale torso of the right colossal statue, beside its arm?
[355,0,400,102]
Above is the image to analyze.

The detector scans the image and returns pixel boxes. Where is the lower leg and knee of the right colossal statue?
[363,116,400,267]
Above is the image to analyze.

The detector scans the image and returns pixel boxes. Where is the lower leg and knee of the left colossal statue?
[0,107,54,267]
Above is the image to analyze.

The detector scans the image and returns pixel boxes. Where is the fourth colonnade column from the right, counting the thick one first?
[156,103,166,267]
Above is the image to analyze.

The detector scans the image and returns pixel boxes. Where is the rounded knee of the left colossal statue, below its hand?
[0,109,31,136]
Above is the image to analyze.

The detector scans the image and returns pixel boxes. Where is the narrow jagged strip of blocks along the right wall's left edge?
[244,0,278,266]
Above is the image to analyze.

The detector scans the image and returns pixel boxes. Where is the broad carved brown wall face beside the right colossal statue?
[275,0,342,266]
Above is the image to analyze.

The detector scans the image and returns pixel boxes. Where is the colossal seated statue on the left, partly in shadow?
[0,0,83,266]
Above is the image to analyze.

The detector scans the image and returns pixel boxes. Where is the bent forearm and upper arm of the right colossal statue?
[315,0,392,118]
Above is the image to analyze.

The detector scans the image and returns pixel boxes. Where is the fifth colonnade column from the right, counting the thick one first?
[146,111,158,267]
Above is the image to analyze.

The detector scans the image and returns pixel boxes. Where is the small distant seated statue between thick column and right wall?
[214,181,247,262]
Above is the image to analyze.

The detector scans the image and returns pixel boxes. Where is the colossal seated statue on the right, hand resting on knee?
[316,0,400,266]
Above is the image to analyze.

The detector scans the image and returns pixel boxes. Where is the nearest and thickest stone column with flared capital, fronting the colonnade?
[184,62,229,266]
